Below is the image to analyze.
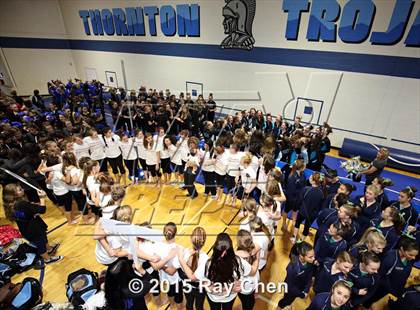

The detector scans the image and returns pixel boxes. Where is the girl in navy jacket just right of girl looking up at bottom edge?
[348,251,381,308]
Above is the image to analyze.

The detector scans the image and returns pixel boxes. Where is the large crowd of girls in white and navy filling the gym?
[0,80,420,310]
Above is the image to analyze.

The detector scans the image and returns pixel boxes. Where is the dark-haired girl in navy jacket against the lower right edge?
[364,236,419,307]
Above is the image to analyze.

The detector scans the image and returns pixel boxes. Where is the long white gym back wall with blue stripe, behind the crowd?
[0,0,420,152]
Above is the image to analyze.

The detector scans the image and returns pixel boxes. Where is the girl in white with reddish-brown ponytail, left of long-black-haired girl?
[178,227,209,310]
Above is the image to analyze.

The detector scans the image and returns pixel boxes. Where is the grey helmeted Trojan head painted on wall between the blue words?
[220,0,256,50]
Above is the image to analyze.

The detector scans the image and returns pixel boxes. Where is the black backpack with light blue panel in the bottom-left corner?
[5,278,43,310]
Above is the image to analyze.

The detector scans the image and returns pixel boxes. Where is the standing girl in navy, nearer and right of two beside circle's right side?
[292,172,324,242]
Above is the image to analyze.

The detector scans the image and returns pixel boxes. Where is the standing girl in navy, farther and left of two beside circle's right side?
[282,159,306,231]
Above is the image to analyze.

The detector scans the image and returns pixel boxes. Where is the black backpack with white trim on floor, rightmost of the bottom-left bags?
[66,268,99,307]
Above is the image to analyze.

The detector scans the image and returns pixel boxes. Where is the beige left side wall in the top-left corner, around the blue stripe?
[0,0,76,95]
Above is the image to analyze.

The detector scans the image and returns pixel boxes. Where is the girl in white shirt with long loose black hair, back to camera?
[205,233,252,310]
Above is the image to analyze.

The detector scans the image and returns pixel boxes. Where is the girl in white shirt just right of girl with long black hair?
[235,230,260,310]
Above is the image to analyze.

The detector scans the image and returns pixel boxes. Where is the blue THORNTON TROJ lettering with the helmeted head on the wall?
[79,0,420,50]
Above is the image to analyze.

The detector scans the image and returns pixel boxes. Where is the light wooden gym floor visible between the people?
[0,151,419,310]
